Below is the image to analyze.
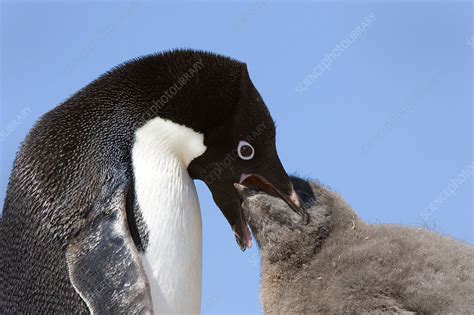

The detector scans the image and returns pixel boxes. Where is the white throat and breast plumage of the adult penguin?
[132,118,206,314]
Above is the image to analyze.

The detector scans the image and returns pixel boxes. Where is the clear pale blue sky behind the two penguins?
[0,0,474,313]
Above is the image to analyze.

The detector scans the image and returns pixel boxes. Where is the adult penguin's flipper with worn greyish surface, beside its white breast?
[66,186,153,314]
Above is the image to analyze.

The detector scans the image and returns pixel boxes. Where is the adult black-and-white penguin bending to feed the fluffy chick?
[0,51,299,314]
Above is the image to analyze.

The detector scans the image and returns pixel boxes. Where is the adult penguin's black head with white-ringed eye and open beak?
[188,61,307,250]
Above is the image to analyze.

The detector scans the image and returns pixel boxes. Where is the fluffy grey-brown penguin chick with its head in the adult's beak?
[237,178,474,314]
